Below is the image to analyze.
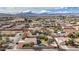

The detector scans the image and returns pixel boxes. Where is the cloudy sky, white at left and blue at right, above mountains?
[0,7,79,14]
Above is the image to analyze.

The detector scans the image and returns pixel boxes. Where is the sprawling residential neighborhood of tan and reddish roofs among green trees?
[0,15,79,51]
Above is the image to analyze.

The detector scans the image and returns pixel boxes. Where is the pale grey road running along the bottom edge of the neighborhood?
[6,48,79,51]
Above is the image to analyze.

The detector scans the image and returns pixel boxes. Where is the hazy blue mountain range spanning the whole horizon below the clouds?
[0,11,79,17]
